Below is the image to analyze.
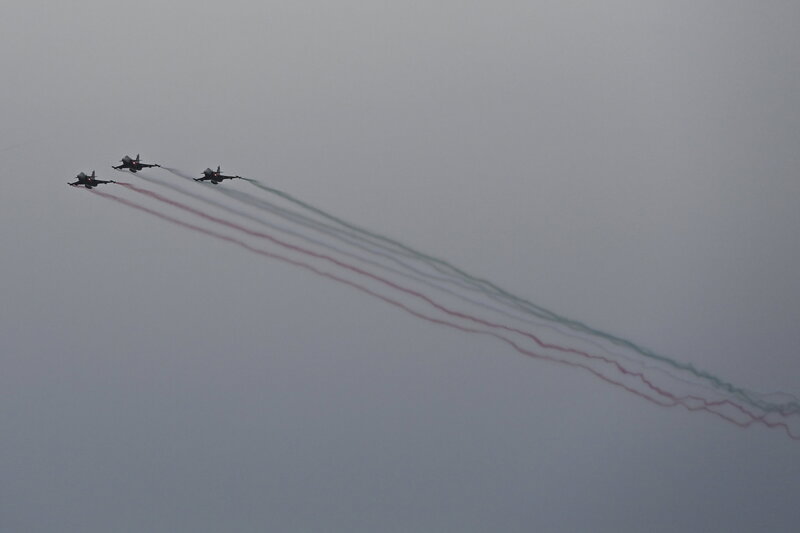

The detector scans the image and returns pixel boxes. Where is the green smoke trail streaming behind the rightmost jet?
[242,178,800,415]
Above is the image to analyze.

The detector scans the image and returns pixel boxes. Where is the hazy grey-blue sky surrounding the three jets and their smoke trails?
[0,0,800,532]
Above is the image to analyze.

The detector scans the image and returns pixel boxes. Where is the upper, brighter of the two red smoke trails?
[114,183,780,428]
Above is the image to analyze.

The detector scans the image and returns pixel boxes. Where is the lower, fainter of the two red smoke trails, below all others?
[90,189,800,440]
